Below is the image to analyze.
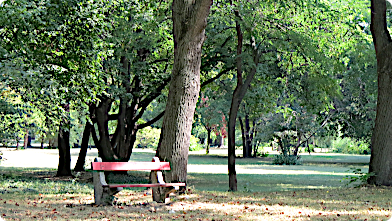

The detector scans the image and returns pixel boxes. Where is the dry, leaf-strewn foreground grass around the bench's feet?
[0,169,392,220]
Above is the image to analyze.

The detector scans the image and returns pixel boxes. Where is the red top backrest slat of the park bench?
[92,162,170,171]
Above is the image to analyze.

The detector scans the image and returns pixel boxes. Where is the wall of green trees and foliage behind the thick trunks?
[0,0,382,190]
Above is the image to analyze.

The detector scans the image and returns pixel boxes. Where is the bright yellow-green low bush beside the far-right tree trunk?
[331,137,370,154]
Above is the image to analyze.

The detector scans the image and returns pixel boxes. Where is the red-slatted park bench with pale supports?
[91,157,185,205]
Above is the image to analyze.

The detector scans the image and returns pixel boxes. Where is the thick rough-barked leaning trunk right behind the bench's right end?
[153,0,212,201]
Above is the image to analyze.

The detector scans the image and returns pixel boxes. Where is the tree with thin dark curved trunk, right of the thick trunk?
[201,1,362,190]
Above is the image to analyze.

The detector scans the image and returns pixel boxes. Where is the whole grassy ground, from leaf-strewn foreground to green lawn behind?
[0,150,392,220]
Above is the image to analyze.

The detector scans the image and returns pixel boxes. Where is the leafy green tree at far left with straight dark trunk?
[0,0,112,176]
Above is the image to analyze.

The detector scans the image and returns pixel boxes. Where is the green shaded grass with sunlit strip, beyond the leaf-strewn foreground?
[124,152,368,192]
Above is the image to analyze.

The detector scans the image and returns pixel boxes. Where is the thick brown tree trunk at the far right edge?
[368,0,392,186]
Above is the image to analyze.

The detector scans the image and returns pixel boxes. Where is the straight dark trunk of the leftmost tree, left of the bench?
[56,104,72,176]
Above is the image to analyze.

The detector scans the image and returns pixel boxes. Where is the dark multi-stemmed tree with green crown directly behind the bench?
[90,1,173,161]
